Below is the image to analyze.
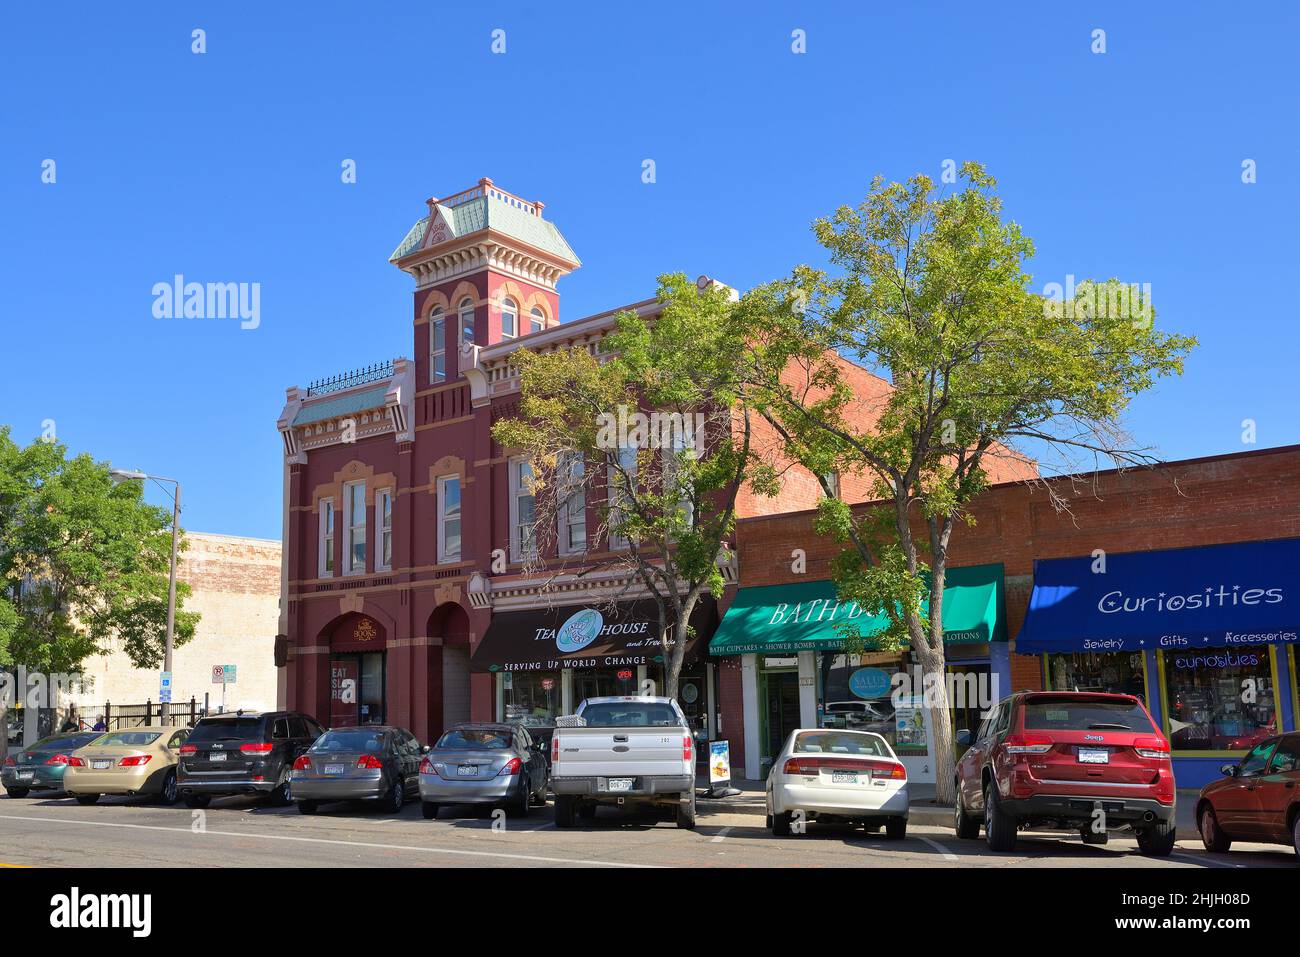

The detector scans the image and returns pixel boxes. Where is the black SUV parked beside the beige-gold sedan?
[176,711,324,807]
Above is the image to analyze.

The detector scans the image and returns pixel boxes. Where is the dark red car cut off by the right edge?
[1196,731,1300,857]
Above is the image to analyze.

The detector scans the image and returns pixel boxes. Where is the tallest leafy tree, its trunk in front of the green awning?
[742,163,1196,801]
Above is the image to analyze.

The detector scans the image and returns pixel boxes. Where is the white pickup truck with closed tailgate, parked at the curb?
[551,697,696,828]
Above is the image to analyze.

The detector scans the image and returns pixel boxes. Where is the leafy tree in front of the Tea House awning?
[493,273,777,697]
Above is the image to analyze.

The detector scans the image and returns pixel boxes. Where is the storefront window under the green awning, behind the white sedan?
[818,651,930,757]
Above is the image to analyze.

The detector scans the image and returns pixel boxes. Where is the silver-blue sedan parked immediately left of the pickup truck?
[420,723,550,820]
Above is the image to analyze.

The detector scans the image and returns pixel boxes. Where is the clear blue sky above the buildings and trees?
[0,3,1300,537]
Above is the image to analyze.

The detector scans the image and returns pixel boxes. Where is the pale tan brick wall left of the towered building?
[78,532,280,720]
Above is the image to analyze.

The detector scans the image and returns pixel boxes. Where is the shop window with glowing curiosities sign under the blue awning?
[1161,645,1278,752]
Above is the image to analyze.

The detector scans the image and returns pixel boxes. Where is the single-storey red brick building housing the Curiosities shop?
[723,446,1300,785]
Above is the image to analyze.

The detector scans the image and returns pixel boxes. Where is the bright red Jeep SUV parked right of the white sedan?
[954,692,1175,857]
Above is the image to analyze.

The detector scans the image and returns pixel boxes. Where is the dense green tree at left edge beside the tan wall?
[0,426,199,748]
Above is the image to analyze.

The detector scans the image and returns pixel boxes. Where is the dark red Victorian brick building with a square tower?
[277,179,1026,741]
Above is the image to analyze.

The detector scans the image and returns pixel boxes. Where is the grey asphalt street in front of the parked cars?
[0,796,1295,869]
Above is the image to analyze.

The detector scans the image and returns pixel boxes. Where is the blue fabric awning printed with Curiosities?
[1015,538,1300,654]
